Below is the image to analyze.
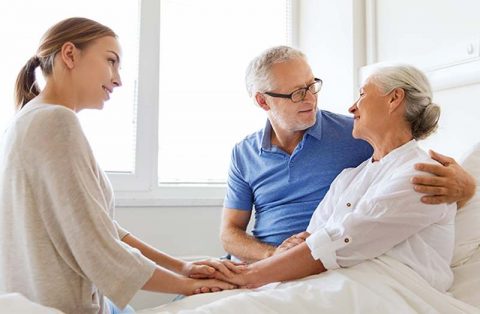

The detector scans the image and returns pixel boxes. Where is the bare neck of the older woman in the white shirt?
[366,128,413,161]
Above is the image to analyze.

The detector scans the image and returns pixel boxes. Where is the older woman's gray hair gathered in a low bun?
[368,65,440,139]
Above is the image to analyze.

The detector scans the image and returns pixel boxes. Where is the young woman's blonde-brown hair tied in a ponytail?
[15,17,117,110]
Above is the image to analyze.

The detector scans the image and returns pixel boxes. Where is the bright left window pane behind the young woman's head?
[0,0,139,173]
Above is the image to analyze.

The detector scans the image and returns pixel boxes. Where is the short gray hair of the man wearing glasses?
[245,46,306,97]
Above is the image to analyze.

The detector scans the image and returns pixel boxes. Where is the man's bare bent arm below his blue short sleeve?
[220,208,276,263]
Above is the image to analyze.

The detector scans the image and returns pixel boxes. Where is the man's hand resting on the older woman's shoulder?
[412,150,476,208]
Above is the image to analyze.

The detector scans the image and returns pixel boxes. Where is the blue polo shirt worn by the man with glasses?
[224,110,373,246]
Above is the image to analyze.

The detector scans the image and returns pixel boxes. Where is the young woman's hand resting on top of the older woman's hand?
[181,258,246,278]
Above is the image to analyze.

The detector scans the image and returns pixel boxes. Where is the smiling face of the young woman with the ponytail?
[75,36,122,111]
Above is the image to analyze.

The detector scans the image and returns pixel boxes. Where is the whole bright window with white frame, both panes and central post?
[0,0,294,206]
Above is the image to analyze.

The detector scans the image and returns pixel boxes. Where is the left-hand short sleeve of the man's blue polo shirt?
[223,144,253,211]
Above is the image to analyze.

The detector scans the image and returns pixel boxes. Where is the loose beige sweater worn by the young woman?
[0,104,155,314]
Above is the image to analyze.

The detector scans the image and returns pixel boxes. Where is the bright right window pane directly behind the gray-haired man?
[158,0,289,183]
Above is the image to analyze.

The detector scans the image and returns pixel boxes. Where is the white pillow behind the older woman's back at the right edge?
[452,143,480,267]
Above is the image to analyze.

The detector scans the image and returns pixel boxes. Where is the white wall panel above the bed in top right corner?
[371,0,480,61]
